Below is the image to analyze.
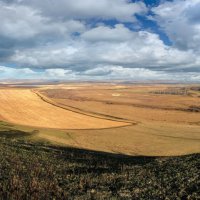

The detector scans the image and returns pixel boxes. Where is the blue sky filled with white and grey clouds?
[0,0,200,82]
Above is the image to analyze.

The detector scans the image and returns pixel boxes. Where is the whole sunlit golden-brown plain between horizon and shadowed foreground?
[0,83,200,156]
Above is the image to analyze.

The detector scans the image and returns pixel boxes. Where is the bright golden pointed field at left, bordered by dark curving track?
[0,89,127,129]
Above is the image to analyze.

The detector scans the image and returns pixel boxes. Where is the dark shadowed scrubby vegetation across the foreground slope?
[0,129,200,200]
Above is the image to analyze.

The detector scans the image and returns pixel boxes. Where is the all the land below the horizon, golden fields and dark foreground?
[0,83,200,199]
